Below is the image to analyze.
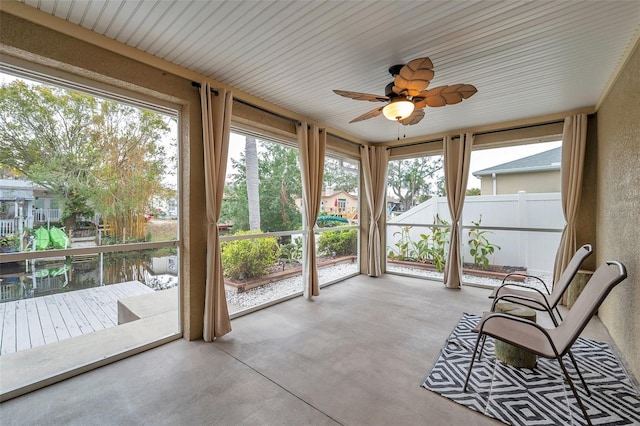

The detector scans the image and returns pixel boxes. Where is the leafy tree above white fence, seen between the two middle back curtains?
[387,156,444,210]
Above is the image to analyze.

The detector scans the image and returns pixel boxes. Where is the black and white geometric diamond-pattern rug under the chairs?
[422,313,640,425]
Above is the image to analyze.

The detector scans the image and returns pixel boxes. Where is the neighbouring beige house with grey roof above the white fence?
[473,147,562,195]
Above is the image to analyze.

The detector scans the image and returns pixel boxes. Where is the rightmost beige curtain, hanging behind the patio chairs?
[553,114,587,303]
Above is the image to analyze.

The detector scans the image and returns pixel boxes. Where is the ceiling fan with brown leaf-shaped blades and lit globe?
[334,58,478,126]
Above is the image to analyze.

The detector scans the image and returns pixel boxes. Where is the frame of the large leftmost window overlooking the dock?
[0,60,185,399]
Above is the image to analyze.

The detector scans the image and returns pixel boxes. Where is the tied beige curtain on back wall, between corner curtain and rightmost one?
[444,133,473,288]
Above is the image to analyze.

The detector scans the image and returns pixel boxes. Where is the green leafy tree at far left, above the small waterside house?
[0,80,100,231]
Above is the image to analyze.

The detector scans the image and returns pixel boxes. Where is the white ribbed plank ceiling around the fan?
[12,0,640,141]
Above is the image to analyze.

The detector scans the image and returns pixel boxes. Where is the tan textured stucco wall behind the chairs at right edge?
[596,38,640,379]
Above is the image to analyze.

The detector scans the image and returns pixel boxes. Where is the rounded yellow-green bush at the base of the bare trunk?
[221,231,278,280]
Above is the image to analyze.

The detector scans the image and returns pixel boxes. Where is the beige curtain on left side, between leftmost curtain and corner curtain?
[296,122,327,299]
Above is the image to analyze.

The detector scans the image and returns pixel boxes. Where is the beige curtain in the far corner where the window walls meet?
[360,146,389,277]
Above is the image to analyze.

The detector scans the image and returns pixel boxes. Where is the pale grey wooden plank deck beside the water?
[0,281,154,355]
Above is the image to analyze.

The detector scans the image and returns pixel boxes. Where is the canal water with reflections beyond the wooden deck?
[0,250,178,302]
